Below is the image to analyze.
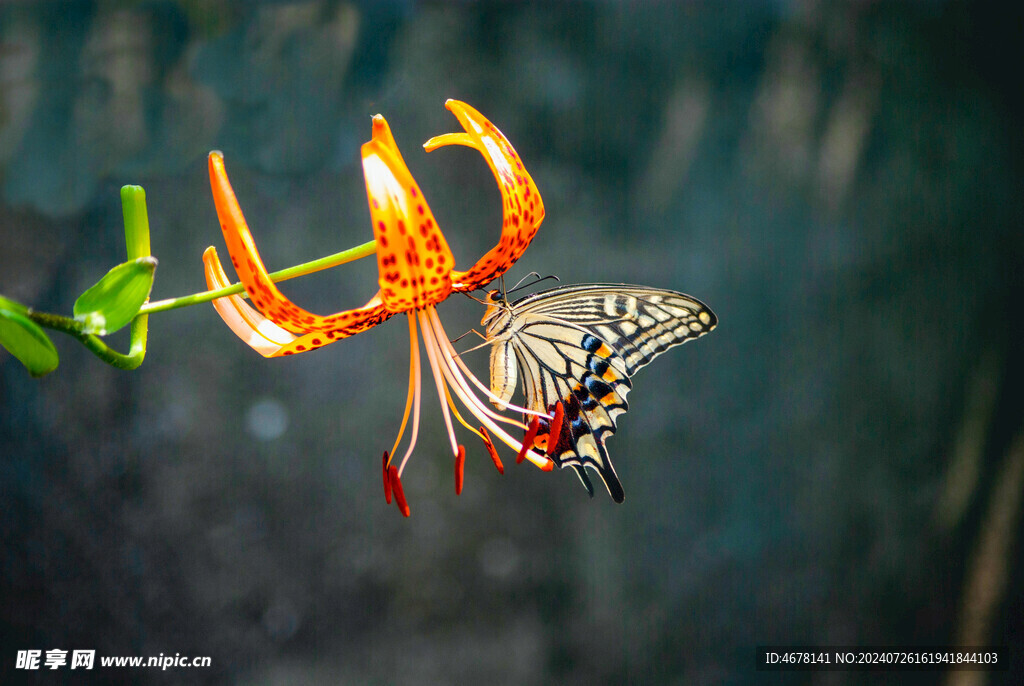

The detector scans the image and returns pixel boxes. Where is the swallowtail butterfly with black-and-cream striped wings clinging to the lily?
[480,284,718,503]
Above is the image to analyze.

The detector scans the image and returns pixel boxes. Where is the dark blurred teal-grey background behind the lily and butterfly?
[0,0,1024,684]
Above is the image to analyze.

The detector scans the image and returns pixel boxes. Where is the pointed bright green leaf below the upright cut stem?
[75,256,157,336]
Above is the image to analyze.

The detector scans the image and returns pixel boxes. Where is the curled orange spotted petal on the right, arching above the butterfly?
[423,100,544,292]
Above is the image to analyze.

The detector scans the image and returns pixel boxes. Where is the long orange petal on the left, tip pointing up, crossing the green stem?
[209,151,391,346]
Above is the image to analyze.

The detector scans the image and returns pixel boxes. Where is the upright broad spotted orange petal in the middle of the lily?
[362,115,455,312]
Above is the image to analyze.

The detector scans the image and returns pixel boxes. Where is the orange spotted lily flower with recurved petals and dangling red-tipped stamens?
[203,100,554,516]
